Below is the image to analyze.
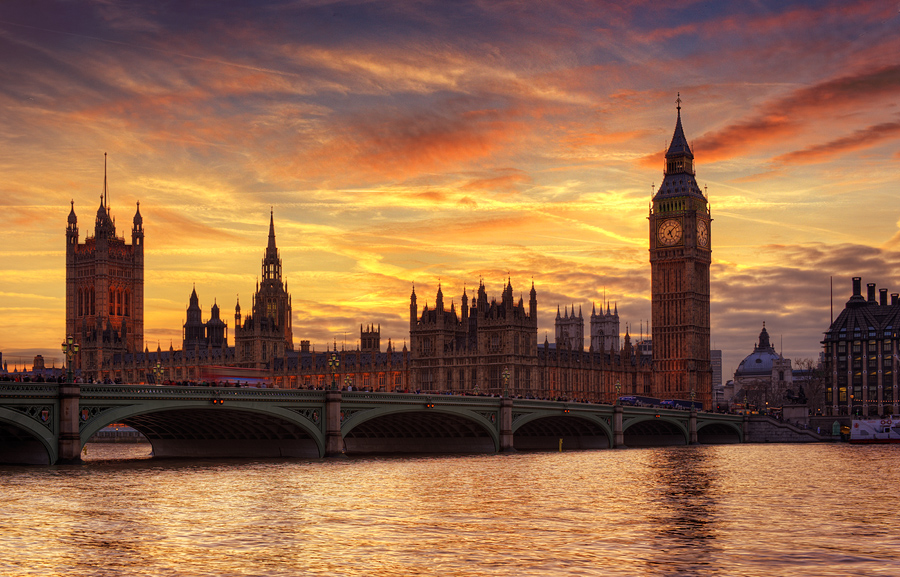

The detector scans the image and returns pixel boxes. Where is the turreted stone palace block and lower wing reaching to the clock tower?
[410,282,653,402]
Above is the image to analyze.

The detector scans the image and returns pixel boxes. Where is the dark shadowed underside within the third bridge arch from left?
[344,411,496,454]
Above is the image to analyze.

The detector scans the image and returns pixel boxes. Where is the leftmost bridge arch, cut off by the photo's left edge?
[0,407,59,465]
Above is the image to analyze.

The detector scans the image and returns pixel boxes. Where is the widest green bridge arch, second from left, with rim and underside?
[80,402,325,458]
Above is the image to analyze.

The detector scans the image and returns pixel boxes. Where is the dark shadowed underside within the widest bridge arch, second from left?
[123,409,319,459]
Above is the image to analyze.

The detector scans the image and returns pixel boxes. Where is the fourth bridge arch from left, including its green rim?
[512,409,613,451]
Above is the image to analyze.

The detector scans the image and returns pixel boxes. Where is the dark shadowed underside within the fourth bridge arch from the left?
[513,417,610,451]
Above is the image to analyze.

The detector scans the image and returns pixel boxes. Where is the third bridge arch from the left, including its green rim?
[341,405,500,454]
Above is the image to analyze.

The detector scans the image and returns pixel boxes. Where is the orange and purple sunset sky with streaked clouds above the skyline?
[0,0,900,379]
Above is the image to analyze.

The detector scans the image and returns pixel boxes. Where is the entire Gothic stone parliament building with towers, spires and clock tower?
[66,99,712,408]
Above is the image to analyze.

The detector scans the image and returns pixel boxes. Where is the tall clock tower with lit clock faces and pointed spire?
[649,95,712,409]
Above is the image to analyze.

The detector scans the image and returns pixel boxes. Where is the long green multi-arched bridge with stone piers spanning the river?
[0,383,747,464]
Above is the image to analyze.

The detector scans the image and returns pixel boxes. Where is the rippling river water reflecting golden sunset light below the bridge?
[0,444,900,577]
